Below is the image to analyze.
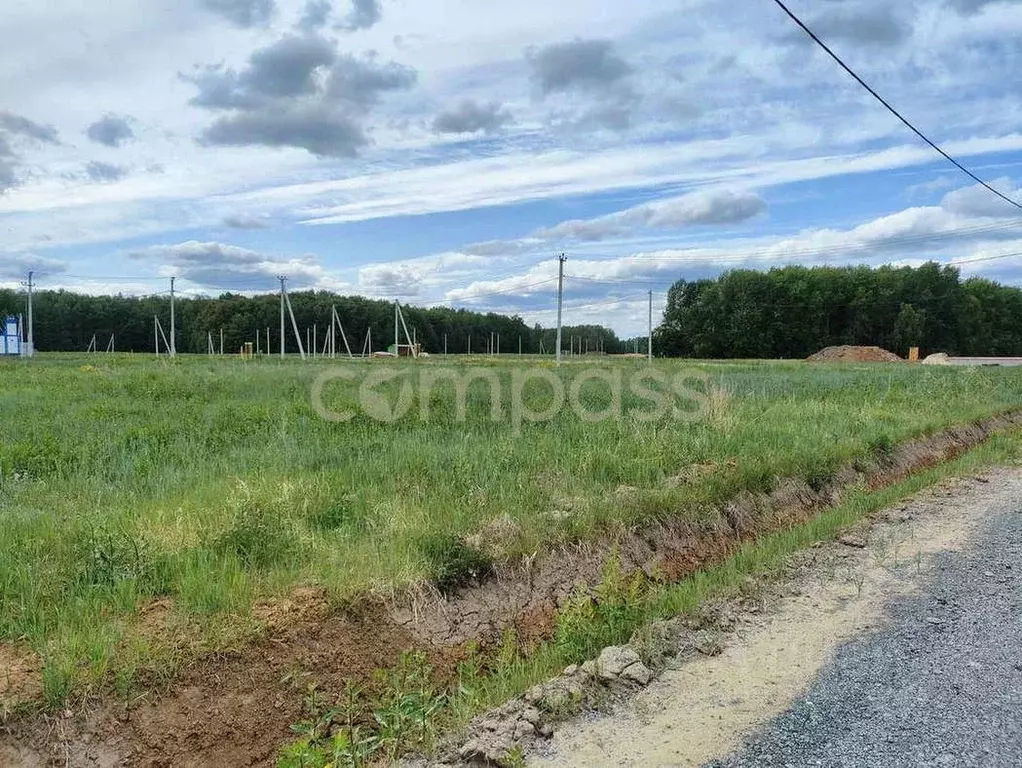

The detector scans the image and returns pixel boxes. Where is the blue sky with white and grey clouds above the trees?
[0,0,1022,336]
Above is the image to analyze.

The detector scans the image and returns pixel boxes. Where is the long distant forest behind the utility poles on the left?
[0,290,623,355]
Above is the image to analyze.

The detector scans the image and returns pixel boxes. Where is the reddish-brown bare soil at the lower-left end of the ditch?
[0,601,431,767]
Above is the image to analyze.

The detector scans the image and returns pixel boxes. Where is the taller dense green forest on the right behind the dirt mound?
[653,262,1022,358]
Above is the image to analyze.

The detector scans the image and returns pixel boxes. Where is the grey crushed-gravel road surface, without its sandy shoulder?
[709,476,1022,768]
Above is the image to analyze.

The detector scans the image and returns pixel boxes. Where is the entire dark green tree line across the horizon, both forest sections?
[7,262,1022,358]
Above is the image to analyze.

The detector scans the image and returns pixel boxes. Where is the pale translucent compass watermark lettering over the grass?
[311,366,712,433]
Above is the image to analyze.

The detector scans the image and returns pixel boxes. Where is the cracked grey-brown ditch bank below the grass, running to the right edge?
[390,411,1022,645]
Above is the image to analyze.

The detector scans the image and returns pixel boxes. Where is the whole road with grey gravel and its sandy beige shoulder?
[528,468,1022,768]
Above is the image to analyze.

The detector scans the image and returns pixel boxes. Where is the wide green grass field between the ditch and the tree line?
[0,355,1022,705]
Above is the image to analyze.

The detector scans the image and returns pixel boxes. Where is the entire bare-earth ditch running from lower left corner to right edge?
[6,411,1022,766]
